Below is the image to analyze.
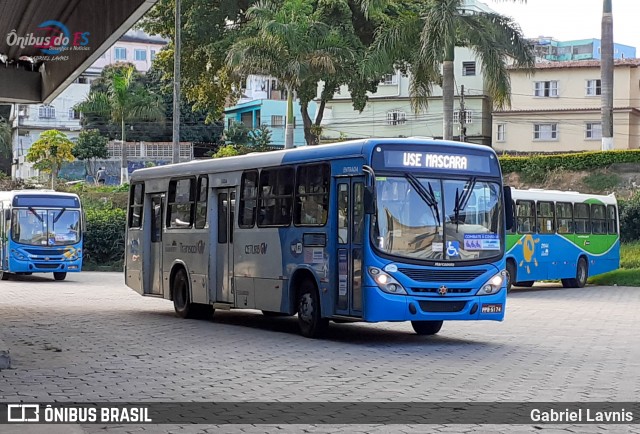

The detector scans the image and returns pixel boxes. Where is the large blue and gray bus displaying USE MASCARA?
[125,138,512,337]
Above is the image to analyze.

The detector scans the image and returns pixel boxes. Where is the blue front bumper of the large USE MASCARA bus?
[363,287,507,322]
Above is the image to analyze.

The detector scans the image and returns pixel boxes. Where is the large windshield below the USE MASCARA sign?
[372,173,504,261]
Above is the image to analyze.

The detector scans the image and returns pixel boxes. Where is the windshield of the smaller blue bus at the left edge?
[11,207,80,246]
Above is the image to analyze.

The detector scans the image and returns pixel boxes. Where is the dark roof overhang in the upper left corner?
[0,0,157,104]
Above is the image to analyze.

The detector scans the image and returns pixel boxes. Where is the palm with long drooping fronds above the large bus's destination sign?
[363,0,535,140]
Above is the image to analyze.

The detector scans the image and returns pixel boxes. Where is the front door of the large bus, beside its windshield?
[336,177,364,317]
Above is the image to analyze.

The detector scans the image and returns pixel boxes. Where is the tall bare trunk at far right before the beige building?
[600,0,613,151]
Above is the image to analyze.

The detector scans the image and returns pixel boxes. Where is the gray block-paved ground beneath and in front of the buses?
[0,272,640,434]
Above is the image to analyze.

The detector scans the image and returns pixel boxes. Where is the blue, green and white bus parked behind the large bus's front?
[506,189,620,289]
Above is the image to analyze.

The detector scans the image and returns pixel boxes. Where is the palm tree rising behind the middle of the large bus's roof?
[227,0,345,149]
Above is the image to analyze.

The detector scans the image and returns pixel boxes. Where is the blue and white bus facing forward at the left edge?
[0,190,84,280]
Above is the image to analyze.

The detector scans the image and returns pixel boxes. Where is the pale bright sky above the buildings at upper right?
[480,0,640,51]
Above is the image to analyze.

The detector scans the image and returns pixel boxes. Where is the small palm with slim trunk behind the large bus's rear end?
[76,65,164,184]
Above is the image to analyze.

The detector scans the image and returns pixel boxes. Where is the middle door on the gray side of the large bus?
[215,188,236,303]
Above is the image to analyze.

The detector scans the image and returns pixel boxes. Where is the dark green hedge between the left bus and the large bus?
[84,208,126,265]
